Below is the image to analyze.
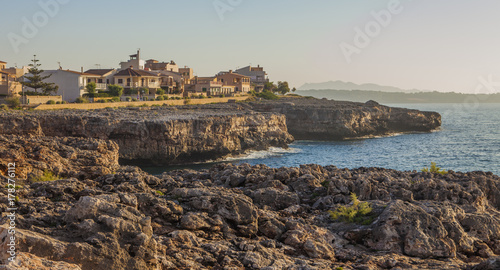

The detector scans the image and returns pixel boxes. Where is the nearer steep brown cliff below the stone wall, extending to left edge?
[0,107,293,164]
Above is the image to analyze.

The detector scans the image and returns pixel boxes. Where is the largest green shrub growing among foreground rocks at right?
[329,193,373,225]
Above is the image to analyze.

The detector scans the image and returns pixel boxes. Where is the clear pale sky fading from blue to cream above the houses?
[0,0,500,93]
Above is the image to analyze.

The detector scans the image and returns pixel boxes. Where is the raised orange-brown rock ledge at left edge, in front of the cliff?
[0,135,120,179]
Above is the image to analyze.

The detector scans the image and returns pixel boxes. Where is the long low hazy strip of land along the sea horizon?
[295,90,500,104]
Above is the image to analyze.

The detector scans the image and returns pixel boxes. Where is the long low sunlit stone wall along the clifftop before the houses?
[35,96,248,110]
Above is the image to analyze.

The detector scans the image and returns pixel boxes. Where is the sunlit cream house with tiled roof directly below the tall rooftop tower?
[113,68,161,89]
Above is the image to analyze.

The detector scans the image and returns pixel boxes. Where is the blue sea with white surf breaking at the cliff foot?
[142,102,500,175]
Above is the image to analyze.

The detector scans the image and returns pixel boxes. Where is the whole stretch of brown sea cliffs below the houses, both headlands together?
[0,98,441,165]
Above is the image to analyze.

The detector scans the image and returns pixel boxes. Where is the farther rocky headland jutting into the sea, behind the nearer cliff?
[251,98,441,140]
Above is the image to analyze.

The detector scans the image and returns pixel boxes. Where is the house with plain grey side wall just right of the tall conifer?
[40,69,100,102]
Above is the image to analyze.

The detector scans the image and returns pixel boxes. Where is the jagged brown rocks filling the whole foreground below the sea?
[0,135,500,270]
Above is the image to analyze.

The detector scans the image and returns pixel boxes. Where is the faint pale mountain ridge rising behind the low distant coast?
[298,81,422,92]
